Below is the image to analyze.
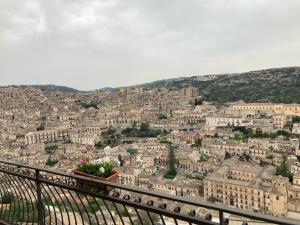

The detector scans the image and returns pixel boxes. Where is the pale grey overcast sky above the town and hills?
[0,0,300,90]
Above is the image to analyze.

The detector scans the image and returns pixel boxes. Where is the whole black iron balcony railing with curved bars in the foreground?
[0,161,300,225]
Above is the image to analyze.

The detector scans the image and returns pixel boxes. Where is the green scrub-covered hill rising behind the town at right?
[142,67,300,103]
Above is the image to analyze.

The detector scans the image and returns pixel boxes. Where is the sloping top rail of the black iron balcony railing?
[0,160,300,225]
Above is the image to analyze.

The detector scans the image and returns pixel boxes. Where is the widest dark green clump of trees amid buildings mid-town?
[121,123,162,138]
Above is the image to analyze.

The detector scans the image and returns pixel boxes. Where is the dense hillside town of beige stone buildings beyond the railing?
[0,86,300,220]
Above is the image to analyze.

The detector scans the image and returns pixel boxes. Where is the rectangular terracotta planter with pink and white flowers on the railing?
[72,160,118,191]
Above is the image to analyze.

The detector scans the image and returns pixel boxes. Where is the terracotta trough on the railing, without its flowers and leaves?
[72,169,119,191]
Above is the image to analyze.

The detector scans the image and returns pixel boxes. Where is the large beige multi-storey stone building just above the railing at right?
[204,161,289,216]
